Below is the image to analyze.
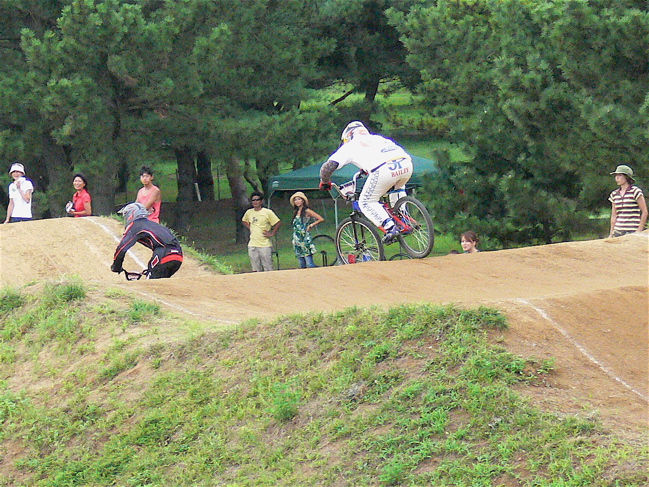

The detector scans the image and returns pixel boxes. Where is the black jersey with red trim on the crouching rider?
[112,218,182,269]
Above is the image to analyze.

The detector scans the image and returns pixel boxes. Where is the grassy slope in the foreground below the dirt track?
[0,284,649,487]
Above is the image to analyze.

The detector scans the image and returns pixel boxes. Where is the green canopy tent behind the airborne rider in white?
[267,156,438,226]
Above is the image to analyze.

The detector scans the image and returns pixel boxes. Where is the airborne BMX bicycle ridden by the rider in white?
[332,171,435,264]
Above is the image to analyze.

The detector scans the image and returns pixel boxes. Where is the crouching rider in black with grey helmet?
[110,203,183,279]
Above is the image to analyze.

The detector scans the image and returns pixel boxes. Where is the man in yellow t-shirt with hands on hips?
[241,191,282,272]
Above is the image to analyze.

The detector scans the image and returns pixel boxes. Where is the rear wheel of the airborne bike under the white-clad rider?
[393,196,435,259]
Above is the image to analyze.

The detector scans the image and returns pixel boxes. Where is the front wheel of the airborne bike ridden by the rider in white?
[336,217,385,264]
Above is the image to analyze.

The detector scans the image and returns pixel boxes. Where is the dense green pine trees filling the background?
[0,0,649,245]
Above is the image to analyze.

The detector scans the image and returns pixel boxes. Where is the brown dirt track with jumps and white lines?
[0,217,649,442]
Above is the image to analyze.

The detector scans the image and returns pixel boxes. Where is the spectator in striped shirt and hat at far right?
[608,164,647,237]
